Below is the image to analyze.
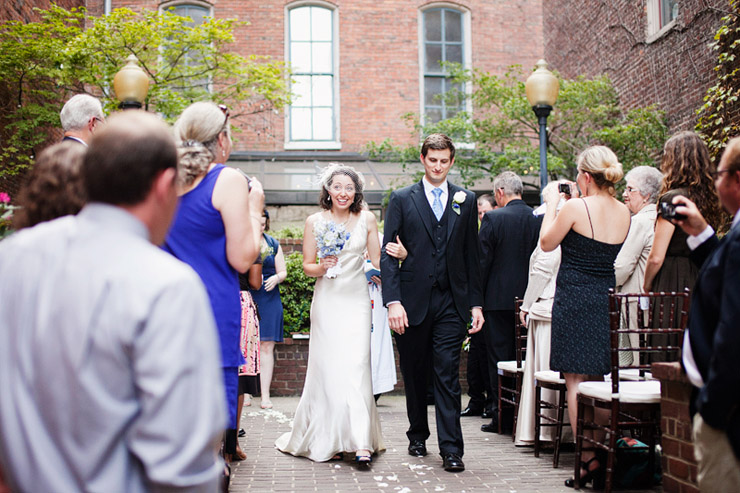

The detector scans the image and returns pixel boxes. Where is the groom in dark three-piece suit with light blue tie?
[380,134,483,472]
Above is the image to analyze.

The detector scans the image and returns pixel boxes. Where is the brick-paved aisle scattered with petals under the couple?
[230,395,662,493]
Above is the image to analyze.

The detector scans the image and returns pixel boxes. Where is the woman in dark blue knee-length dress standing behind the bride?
[247,209,288,409]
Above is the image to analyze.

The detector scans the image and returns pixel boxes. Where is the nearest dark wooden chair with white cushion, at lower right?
[574,289,689,493]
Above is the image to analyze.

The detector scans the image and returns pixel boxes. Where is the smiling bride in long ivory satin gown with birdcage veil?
[275,163,385,465]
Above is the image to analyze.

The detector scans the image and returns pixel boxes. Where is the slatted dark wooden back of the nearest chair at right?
[609,289,689,394]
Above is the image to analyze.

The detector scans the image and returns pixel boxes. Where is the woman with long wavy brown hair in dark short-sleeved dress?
[643,132,722,292]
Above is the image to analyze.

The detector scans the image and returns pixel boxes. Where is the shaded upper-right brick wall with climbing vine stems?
[544,0,729,131]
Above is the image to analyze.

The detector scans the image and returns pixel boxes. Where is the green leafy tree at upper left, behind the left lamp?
[0,5,289,183]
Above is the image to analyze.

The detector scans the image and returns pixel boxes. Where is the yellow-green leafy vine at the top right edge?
[696,0,740,158]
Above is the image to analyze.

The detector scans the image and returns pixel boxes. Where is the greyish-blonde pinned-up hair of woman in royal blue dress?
[174,102,231,186]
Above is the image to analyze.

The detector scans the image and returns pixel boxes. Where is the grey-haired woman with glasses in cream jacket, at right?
[614,166,663,365]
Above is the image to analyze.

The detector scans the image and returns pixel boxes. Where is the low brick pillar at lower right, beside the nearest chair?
[652,362,699,493]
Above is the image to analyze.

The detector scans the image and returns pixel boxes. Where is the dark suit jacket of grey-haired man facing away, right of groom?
[478,199,542,310]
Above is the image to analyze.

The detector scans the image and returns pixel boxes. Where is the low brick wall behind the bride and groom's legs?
[270,330,468,396]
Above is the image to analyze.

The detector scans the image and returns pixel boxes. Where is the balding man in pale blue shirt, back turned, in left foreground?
[0,112,226,492]
